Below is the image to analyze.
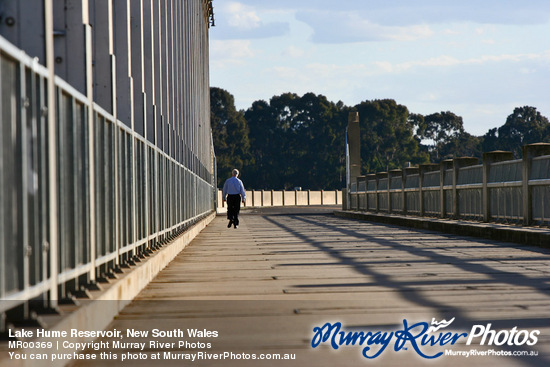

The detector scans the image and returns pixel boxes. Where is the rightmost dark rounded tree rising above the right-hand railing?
[482,106,550,158]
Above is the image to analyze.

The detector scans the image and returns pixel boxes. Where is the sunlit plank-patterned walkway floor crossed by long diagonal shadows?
[75,208,550,366]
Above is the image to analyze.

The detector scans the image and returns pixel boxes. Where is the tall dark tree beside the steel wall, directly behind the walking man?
[210,87,253,186]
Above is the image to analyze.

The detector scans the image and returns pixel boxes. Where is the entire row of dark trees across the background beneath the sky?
[210,87,550,190]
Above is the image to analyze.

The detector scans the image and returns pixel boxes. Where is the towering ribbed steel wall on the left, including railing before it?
[0,0,215,320]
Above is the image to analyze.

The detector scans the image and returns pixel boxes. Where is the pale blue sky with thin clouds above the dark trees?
[210,0,550,135]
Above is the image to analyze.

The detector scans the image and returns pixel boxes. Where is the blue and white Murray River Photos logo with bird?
[311,318,540,359]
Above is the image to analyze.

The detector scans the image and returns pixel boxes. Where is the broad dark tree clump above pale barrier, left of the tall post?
[245,93,346,189]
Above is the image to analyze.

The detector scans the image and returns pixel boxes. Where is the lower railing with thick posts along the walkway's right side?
[344,143,550,226]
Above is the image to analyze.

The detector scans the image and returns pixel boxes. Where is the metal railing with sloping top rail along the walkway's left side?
[0,37,215,316]
